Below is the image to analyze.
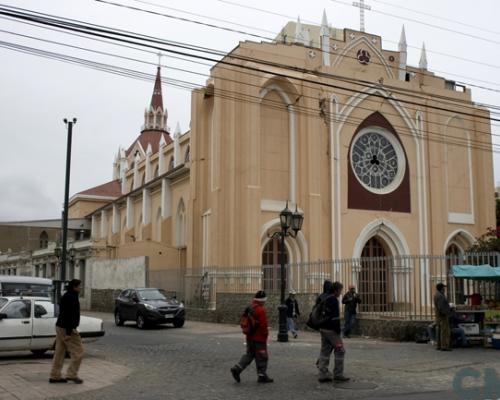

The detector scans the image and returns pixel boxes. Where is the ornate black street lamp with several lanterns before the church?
[268,201,304,342]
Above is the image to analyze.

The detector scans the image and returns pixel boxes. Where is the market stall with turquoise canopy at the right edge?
[451,265,500,348]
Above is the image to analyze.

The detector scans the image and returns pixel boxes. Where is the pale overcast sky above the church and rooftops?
[0,0,500,221]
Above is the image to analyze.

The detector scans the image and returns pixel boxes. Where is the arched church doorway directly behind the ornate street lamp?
[262,238,289,293]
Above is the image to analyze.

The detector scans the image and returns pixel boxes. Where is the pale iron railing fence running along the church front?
[152,253,500,320]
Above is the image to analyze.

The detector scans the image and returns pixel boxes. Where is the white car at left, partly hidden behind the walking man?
[0,296,104,354]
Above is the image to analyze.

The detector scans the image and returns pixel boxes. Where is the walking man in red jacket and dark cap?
[231,290,273,383]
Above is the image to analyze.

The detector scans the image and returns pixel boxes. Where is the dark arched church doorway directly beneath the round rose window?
[358,236,391,312]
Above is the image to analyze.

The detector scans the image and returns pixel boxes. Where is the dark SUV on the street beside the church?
[115,288,186,329]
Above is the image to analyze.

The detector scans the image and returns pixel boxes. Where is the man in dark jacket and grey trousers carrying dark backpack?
[318,282,349,382]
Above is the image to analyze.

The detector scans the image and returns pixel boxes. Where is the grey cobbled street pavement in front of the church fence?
[0,314,500,400]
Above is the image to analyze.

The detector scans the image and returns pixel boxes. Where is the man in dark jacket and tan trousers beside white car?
[49,279,83,383]
